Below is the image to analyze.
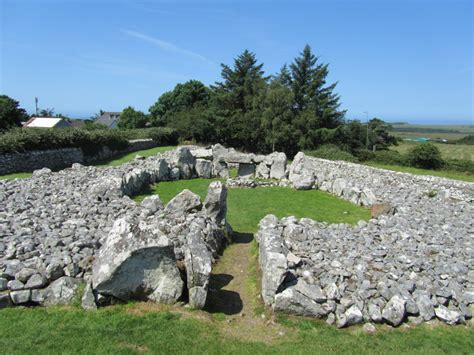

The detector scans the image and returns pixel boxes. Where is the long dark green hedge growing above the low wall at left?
[0,128,177,155]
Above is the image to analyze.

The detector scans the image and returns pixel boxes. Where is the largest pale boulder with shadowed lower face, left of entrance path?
[92,218,183,303]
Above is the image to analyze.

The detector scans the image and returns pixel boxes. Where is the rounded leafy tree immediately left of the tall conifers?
[149,80,210,126]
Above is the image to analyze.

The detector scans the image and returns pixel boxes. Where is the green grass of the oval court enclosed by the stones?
[135,179,370,233]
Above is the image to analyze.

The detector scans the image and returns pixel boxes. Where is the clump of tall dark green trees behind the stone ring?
[150,46,395,157]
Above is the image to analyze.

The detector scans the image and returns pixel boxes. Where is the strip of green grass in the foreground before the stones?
[0,305,474,354]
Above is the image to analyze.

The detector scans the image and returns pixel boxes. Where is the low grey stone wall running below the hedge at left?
[0,139,156,175]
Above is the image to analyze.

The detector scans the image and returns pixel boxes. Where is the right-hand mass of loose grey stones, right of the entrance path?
[257,153,474,327]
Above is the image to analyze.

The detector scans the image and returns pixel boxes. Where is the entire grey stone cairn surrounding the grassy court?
[0,145,474,327]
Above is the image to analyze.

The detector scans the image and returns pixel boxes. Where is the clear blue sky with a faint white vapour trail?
[0,0,474,124]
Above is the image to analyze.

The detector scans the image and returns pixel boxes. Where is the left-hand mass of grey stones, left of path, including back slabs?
[0,145,287,308]
